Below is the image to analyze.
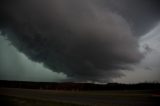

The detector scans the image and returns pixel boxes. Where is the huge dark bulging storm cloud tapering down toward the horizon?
[0,0,158,81]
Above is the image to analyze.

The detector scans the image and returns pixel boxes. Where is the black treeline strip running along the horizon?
[0,80,160,91]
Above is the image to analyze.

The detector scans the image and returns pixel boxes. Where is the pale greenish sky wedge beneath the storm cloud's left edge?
[0,36,66,81]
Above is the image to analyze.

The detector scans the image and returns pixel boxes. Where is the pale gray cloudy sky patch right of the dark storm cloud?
[114,24,160,83]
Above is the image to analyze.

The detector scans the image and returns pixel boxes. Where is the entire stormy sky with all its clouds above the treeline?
[0,0,160,82]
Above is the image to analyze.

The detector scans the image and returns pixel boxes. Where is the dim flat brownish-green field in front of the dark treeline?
[0,88,160,106]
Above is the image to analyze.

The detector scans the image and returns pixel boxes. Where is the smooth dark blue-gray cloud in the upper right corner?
[95,0,160,36]
